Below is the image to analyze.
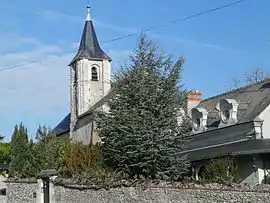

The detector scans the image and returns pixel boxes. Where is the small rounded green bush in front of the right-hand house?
[202,158,238,184]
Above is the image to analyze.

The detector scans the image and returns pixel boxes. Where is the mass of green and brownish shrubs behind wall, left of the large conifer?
[8,125,110,181]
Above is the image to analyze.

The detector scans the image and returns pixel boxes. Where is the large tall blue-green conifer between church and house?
[97,35,189,180]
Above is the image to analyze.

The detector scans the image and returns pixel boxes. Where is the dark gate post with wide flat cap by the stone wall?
[38,169,57,203]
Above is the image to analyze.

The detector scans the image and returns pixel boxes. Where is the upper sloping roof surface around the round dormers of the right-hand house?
[197,78,270,129]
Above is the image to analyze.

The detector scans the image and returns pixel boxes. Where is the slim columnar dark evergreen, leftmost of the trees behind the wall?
[10,123,29,176]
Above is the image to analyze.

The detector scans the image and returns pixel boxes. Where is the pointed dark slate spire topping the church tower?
[69,6,111,65]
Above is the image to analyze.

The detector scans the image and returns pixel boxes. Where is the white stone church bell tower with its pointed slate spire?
[69,6,111,136]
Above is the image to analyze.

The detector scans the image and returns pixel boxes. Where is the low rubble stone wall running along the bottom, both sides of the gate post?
[7,183,270,203]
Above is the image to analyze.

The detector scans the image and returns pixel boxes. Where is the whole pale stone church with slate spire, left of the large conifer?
[53,7,112,144]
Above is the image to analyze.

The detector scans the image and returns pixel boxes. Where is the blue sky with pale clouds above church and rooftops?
[0,0,270,139]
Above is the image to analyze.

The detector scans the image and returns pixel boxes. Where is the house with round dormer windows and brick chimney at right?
[182,79,270,184]
